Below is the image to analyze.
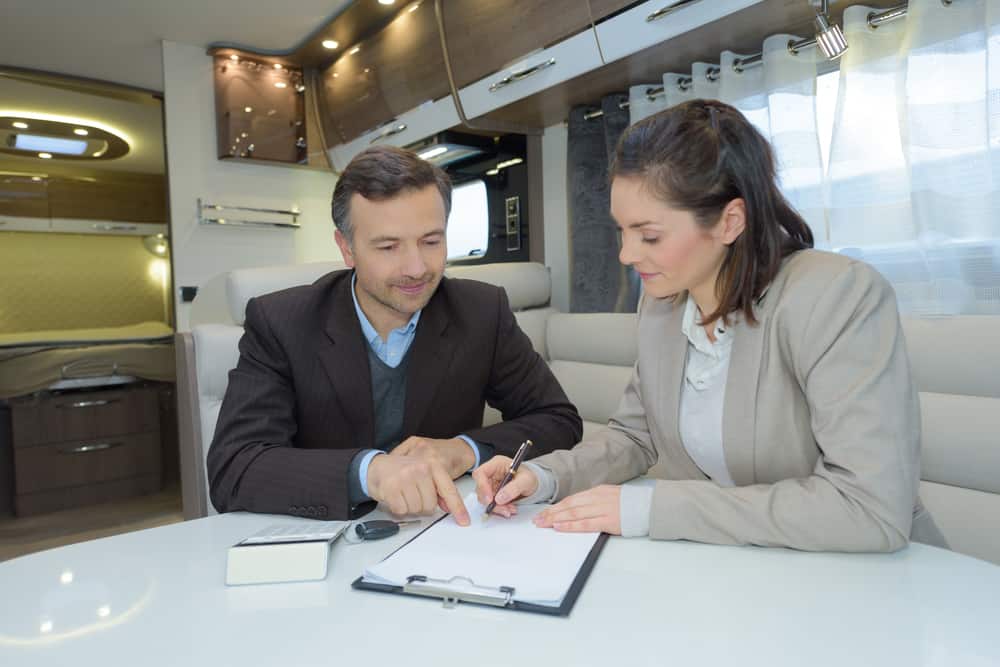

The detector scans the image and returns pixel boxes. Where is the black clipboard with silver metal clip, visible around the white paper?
[351,514,610,616]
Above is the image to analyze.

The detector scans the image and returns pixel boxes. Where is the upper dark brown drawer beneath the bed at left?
[11,387,160,448]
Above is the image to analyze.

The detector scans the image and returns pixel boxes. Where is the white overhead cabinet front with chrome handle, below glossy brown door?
[459,29,602,118]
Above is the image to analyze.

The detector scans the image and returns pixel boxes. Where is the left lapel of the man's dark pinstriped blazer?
[318,276,375,448]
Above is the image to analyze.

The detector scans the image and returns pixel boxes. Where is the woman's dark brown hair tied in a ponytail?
[610,100,813,324]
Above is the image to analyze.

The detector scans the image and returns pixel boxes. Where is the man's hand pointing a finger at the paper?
[368,454,469,526]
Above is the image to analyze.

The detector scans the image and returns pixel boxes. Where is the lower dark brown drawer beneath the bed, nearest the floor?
[14,433,160,495]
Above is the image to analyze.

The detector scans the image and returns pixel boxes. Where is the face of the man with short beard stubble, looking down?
[336,185,448,326]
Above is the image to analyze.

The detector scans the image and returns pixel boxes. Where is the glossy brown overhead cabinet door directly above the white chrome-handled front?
[443,0,590,88]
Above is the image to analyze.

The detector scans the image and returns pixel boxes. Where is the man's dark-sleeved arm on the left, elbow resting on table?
[207,299,374,519]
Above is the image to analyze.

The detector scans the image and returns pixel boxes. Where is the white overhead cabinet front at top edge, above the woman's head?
[597,0,763,63]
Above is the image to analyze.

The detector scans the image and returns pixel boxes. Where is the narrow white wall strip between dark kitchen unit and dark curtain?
[542,123,569,312]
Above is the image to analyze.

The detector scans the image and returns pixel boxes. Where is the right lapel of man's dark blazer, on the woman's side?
[403,286,457,437]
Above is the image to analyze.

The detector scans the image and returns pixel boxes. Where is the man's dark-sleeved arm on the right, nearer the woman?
[464,289,583,457]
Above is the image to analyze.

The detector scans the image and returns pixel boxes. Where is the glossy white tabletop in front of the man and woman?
[0,480,1000,667]
